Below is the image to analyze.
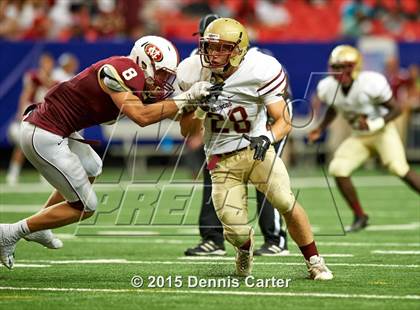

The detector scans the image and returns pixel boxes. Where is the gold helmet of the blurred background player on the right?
[328,45,363,79]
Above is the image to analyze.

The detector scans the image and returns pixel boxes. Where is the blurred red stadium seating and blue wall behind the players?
[0,0,420,167]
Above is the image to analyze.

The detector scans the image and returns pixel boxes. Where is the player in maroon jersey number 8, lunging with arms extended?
[0,36,211,269]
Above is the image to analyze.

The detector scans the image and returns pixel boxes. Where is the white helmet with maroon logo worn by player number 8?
[129,36,179,101]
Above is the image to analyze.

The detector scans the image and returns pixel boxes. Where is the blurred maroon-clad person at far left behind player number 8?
[6,53,56,185]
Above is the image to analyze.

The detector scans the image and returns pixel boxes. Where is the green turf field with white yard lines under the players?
[0,167,420,310]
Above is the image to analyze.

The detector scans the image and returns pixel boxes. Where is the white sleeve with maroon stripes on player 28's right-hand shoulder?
[257,57,288,105]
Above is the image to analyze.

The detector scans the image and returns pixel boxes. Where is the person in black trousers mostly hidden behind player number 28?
[184,14,289,256]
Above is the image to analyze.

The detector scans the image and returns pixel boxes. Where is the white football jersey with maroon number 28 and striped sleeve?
[177,49,291,156]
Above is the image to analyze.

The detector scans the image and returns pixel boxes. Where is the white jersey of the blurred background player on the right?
[317,71,392,123]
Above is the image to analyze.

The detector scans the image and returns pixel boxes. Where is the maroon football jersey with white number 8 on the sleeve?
[25,57,145,137]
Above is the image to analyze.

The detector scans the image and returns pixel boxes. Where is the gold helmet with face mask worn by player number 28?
[198,18,249,69]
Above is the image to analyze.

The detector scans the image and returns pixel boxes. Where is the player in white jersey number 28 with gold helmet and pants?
[177,18,333,280]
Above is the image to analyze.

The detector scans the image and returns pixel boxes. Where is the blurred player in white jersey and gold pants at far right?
[308,45,420,232]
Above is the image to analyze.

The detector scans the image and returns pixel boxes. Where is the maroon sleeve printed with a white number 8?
[108,57,145,91]
